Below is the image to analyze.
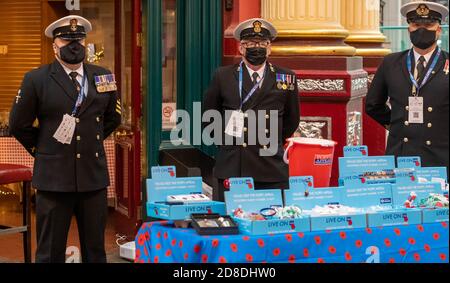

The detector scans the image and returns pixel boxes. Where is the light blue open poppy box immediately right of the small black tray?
[225,178,310,235]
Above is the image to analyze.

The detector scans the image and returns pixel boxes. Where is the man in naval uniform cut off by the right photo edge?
[366,1,449,175]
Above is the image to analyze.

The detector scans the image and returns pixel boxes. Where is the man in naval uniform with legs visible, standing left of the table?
[9,16,121,263]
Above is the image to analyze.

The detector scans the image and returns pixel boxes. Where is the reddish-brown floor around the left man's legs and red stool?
[0,187,127,263]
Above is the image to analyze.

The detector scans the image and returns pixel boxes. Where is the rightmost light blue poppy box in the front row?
[392,169,449,223]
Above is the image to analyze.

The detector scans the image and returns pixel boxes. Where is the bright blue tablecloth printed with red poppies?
[135,222,449,263]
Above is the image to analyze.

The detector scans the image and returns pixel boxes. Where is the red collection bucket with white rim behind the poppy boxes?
[284,138,337,188]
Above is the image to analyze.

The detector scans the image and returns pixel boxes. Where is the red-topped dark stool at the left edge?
[0,164,33,263]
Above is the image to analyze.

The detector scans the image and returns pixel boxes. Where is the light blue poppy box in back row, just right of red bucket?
[339,146,395,186]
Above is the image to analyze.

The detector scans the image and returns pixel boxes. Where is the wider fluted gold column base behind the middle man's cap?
[261,0,361,56]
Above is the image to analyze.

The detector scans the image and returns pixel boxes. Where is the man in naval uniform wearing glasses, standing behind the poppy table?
[203,19,300,200]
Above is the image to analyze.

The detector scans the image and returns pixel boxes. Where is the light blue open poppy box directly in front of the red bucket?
[284,176,367,232]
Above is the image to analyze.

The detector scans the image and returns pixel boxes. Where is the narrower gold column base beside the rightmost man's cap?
[341,0,391,56]
